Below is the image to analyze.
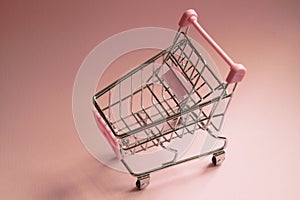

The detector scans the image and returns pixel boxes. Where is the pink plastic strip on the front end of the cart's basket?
[93,109,122,159]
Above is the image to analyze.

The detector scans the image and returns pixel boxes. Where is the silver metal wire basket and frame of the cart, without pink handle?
[93,29,237,188]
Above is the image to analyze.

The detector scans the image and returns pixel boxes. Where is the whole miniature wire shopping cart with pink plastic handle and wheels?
[93,10,246,189]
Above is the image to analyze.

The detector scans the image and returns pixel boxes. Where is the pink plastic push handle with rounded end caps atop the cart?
[179,9,246,83]
